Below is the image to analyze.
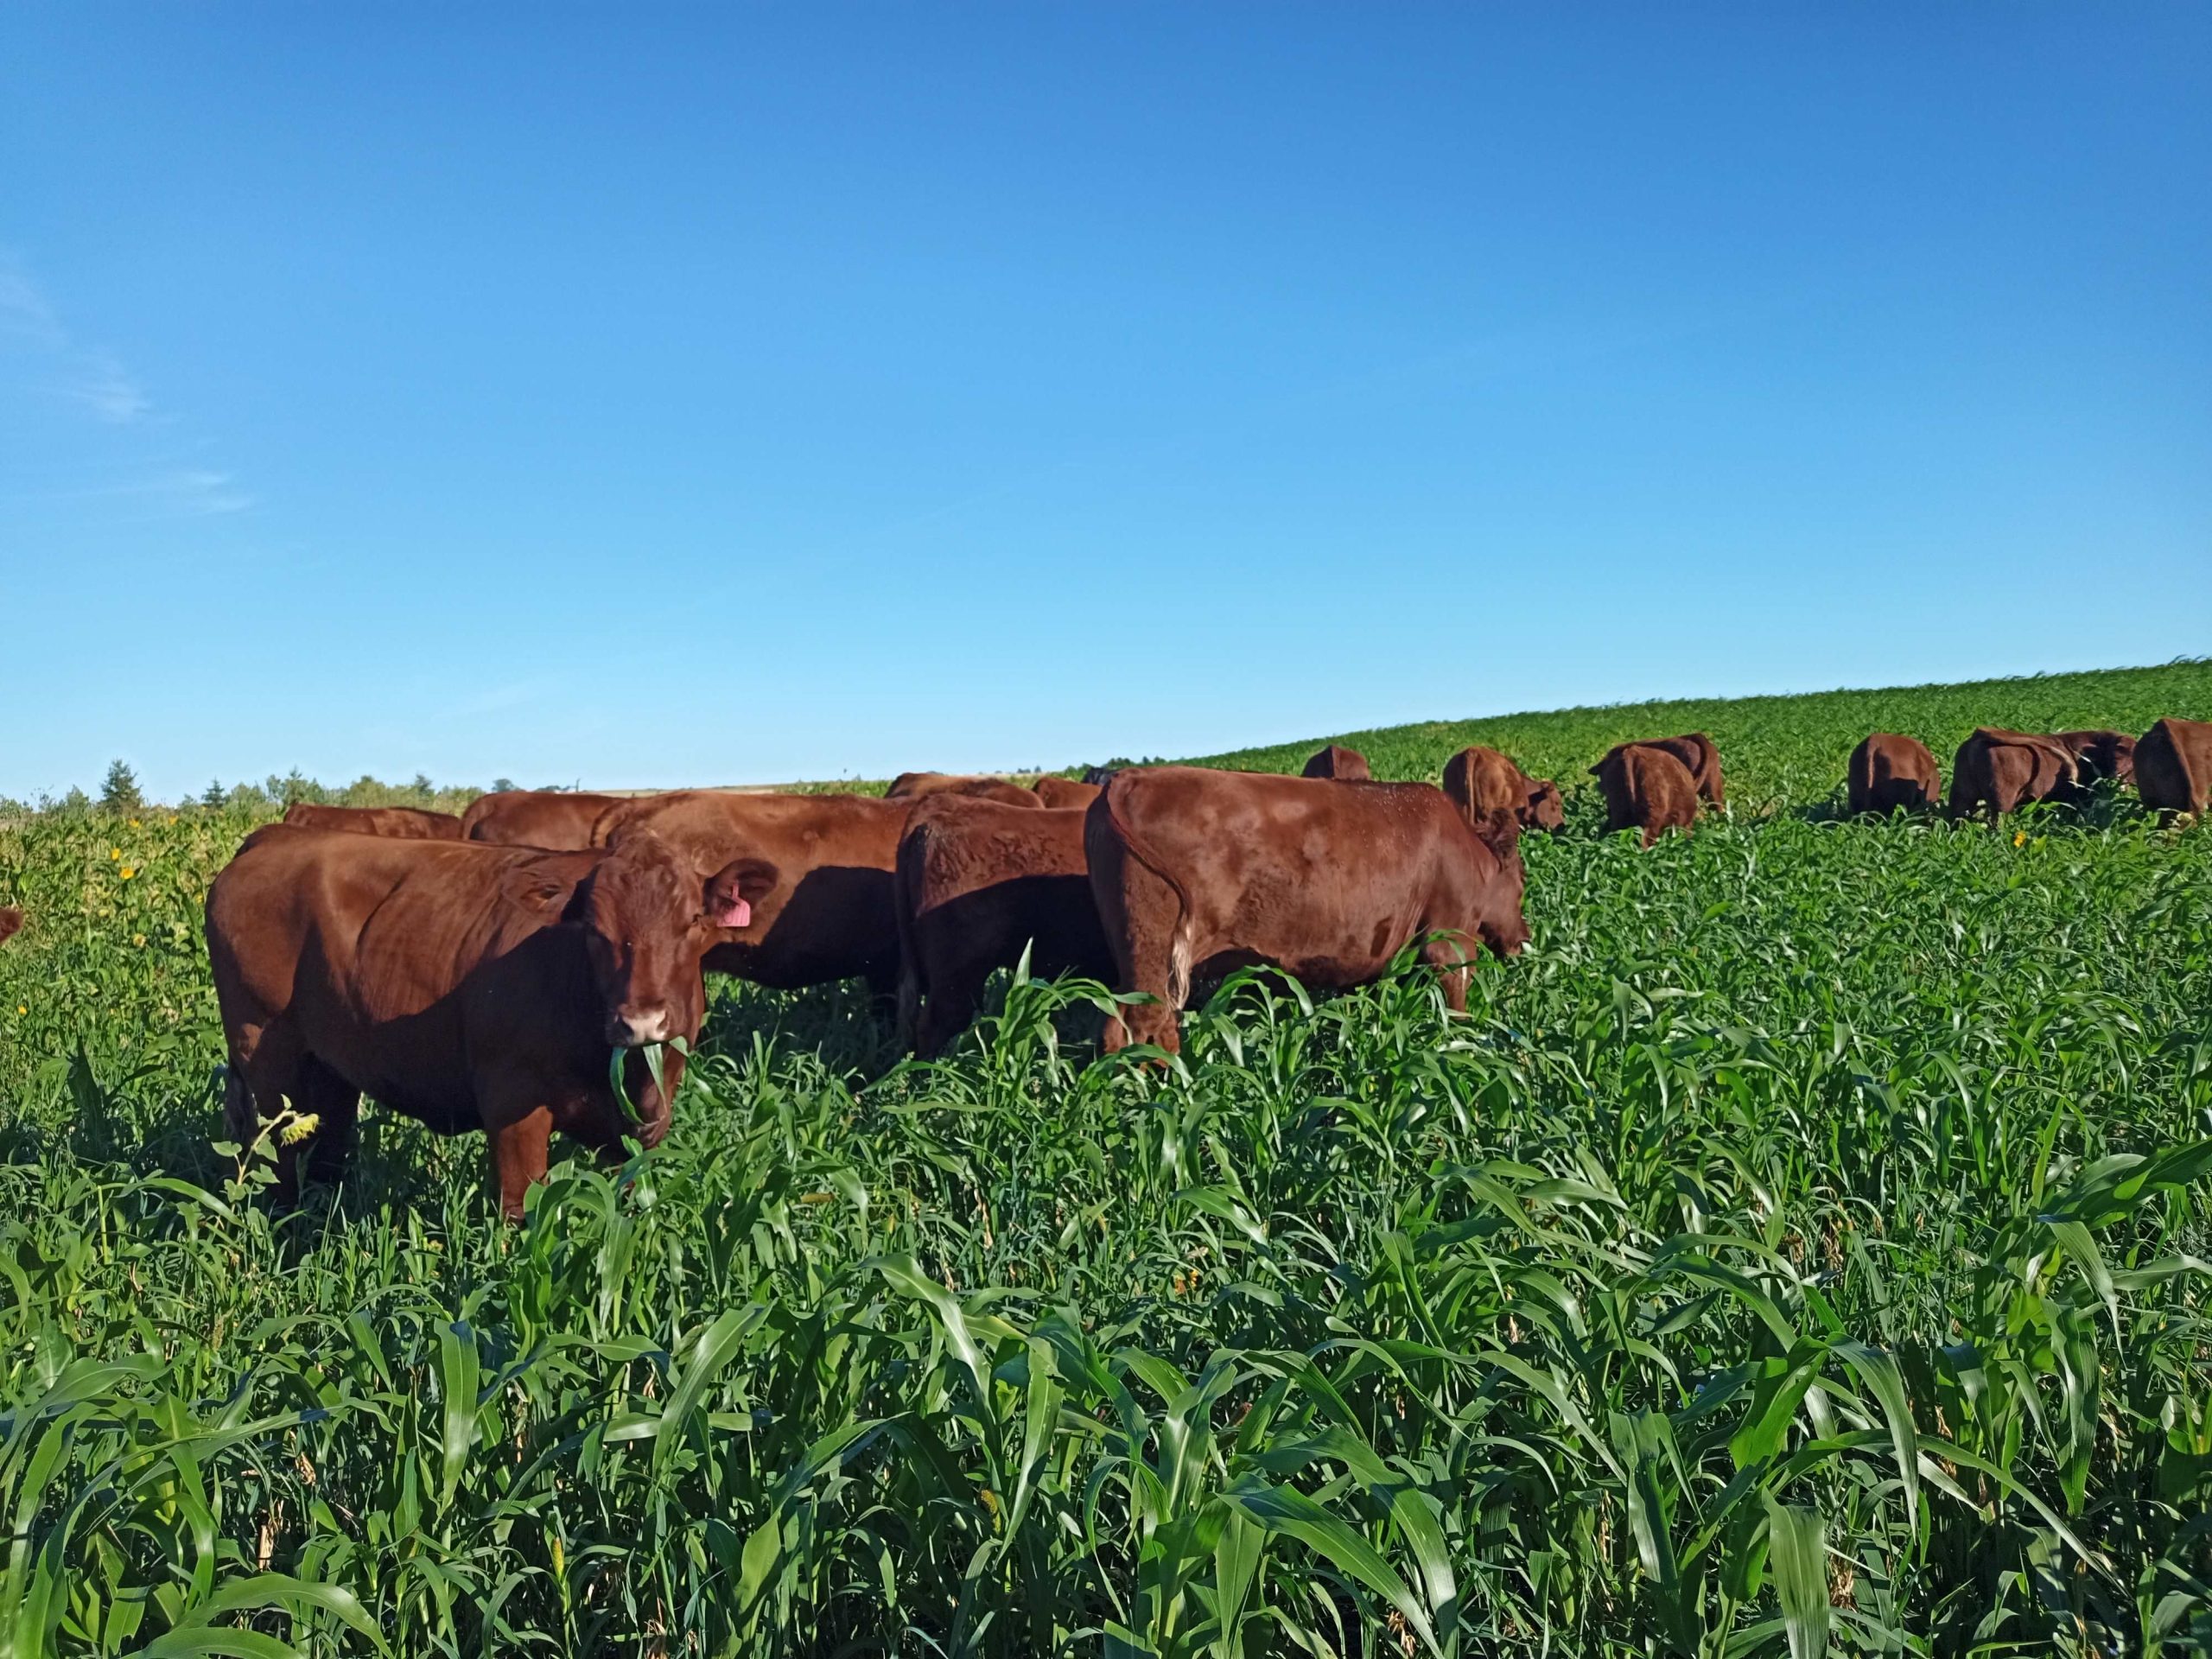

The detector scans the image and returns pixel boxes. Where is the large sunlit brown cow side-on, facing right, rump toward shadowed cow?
[1084,766,1529,1048]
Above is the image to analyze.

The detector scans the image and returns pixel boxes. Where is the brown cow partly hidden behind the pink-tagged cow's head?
[600,790,915,1000]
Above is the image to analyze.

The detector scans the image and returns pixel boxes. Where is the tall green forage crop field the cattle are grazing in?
[0,661,2212,1659]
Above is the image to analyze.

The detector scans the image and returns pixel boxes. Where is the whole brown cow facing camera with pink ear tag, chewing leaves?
[208,825,777,1217]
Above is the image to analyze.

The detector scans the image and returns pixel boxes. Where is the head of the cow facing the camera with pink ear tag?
[569,834,777,1048]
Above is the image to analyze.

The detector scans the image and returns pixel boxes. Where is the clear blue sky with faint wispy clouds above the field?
[0,0,2212,797]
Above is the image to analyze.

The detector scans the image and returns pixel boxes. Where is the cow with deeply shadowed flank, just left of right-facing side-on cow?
[896,794,1113,1055]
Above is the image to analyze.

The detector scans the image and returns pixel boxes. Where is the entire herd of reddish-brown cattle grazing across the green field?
[0,719,2212,1214]
